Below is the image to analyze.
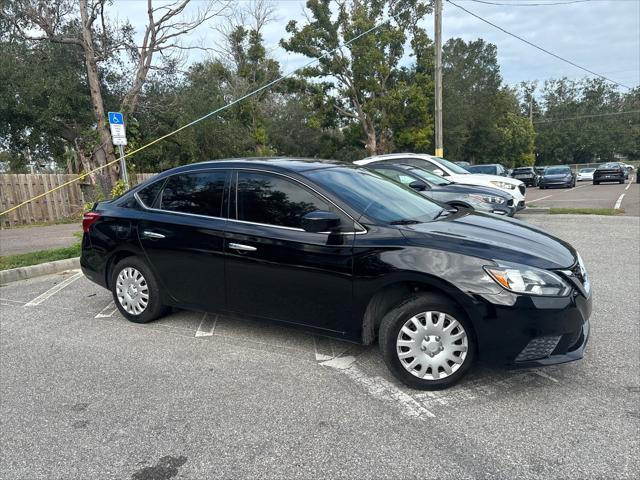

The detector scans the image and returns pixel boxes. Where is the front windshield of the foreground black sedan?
[306,167,443,224]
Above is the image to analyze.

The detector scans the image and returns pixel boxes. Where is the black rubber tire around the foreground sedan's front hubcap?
[378,293,476,390]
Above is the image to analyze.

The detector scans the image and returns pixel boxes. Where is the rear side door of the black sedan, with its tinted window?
[138,169,230,310]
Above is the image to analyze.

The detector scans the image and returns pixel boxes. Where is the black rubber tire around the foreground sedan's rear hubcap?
[110,257,168,323]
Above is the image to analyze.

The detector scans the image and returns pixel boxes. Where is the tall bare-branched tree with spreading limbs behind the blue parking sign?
[3,0,228,187]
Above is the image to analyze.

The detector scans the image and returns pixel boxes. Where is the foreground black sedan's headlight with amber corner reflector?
[484,265,571,297]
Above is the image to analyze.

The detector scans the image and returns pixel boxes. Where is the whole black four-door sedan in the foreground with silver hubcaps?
[80,159,592,389]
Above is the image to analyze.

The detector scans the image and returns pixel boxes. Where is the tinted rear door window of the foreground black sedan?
[159,170,227,217]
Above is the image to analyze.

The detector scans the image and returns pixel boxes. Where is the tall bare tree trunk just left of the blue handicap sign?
[79,0,119,187]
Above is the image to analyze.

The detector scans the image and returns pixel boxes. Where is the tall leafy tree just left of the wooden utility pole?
[280,0,431,155]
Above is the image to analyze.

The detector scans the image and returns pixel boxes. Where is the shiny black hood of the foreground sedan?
[399,210,577,269]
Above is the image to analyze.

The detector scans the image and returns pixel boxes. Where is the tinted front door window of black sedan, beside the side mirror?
[236,172,332,228]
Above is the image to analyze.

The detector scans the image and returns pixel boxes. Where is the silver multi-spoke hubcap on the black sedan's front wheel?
[396,312,469,380]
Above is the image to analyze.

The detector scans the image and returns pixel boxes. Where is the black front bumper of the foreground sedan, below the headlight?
[474,284,592,367]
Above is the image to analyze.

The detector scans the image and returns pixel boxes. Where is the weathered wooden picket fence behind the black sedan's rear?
[0,173,154,228]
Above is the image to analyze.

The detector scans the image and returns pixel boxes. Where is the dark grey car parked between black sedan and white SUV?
[369,163,516,217]
